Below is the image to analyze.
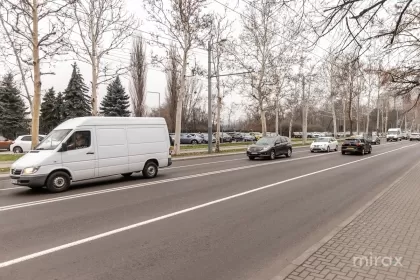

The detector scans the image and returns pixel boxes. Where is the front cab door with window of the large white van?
[61,129,96,181]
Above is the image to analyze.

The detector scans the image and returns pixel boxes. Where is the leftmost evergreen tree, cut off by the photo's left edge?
[0,74,29,139]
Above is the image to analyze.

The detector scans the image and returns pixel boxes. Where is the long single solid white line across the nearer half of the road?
[0,144,416,268]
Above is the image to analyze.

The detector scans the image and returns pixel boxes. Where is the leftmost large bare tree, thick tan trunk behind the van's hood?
[0,0,73,147]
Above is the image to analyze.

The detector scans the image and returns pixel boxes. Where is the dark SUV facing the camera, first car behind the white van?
[246,136,292,160]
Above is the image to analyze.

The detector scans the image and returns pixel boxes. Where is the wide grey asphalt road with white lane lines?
[0,141,420,280]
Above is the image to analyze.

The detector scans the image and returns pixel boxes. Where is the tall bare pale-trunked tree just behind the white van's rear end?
[144,0,210,154]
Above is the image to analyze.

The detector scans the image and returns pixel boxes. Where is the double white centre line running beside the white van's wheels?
[0,153,334,212]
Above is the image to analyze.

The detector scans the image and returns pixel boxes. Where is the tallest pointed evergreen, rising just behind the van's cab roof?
[63,63,91,119]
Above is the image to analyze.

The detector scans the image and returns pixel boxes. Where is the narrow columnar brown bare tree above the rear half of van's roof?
[130,36,147,117]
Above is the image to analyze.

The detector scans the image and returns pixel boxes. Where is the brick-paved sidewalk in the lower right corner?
[273,161,420,280]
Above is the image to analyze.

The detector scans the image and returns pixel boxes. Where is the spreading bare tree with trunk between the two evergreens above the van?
[71,0,138,116]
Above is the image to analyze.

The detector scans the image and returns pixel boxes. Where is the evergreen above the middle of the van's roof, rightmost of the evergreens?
[100,76,130,117]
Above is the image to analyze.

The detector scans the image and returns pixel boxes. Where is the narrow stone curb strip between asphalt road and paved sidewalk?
[271,158,420,280]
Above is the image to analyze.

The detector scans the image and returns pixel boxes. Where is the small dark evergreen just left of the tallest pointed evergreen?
[39,88,60,134]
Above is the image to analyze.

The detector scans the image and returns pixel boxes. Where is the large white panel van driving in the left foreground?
[10,117,172,192]
